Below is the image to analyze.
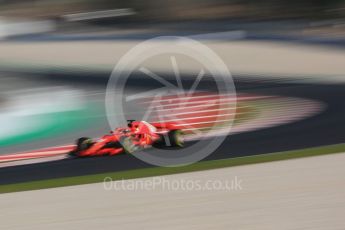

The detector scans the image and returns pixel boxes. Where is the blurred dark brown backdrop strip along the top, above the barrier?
[0,0,345,38]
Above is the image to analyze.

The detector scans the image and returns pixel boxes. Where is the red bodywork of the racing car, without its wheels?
[72,121,177,157]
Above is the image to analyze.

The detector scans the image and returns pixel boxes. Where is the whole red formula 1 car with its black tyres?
[69,120,184,157]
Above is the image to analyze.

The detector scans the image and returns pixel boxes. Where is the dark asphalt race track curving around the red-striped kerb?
[0,73,345,185]
